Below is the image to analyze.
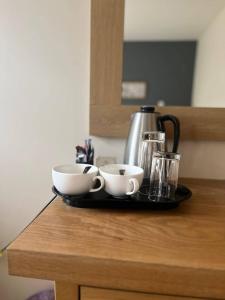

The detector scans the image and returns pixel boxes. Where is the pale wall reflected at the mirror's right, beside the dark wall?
[192,4,225,107]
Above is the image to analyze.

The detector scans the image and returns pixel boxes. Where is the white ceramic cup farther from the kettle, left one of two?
[52,164,104,195]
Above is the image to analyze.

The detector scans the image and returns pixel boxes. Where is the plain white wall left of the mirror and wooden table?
[0,0,90,300]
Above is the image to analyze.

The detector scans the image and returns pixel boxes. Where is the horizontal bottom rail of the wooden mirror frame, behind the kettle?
[90,105,225,141]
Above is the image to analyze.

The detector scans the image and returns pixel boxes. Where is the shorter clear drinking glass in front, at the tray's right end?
[149,152,180,201]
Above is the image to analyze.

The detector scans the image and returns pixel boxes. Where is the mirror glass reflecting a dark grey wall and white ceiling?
[122,0,225,107]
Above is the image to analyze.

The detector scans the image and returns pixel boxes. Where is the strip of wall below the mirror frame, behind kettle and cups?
[94,137,225,180]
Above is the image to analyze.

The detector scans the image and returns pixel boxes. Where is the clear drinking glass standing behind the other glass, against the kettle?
[138,131,165,178]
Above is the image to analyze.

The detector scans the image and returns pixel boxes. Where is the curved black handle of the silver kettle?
[157,115,180,153]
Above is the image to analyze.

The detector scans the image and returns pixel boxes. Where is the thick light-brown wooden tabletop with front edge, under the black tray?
[8,179,225,299]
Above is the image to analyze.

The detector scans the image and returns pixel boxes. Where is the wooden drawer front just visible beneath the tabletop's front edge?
[80,287,203,300]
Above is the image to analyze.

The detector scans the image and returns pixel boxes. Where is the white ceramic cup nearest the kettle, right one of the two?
[99,164,144,197]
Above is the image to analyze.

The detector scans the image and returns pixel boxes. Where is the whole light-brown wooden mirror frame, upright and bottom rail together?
[90,0,225,141]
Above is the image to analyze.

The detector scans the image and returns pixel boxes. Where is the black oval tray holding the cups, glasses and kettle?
[52,184,192,210]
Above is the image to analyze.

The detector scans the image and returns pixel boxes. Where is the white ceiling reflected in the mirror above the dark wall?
[124,0,225,40]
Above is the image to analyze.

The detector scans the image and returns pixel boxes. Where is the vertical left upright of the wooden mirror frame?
[90,0,124,105]
